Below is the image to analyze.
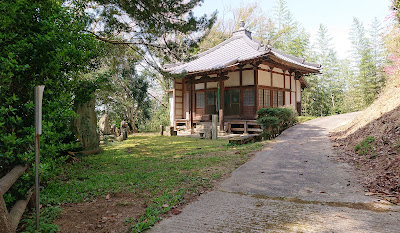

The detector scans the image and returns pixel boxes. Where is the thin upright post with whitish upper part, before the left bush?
[35,85,44,231]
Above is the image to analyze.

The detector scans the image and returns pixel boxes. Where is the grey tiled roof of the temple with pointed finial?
[164,27,321,74]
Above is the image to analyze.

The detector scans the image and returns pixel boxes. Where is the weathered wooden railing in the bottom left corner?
[0,165,33,233]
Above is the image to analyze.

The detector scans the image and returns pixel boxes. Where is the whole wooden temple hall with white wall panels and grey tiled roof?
[164,22,321,133]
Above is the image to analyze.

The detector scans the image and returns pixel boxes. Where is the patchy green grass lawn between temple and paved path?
[25,134,263,232]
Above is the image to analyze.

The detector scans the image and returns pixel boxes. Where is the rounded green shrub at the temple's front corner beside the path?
[257,108,297,139]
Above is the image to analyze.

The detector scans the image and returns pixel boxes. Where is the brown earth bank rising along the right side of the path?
[331,84,400,203]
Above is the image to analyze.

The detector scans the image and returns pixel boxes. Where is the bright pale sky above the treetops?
[194,0,391,58]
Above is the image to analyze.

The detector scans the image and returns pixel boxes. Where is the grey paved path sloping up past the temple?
[151,113,400,232]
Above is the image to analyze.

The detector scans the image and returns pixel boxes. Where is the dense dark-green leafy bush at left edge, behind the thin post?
[0,0,101,206]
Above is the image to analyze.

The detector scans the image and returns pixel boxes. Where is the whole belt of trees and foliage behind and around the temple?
[0,0,399,220]
